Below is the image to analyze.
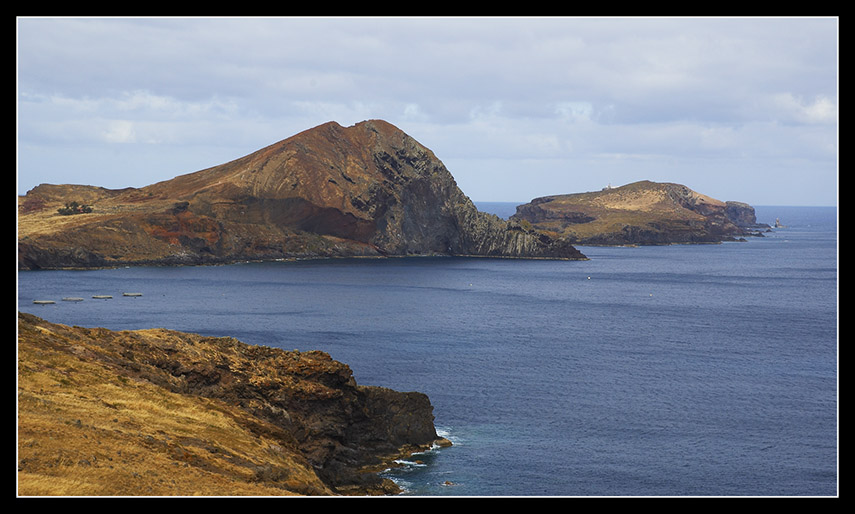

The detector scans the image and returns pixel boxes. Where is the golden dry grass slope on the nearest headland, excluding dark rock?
[18,320,330,496]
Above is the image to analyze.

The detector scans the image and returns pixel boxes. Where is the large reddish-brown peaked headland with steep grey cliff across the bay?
[18,120,585,268]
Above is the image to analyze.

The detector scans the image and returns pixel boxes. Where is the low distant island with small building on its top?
[511,181,770,245]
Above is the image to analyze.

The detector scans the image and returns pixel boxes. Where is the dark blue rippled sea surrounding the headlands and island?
[18,203,839,496]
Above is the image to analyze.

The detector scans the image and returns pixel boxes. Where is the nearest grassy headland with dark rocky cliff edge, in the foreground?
[18,313,444,496]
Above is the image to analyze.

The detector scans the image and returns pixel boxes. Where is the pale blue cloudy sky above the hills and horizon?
[16,17,839,206]
